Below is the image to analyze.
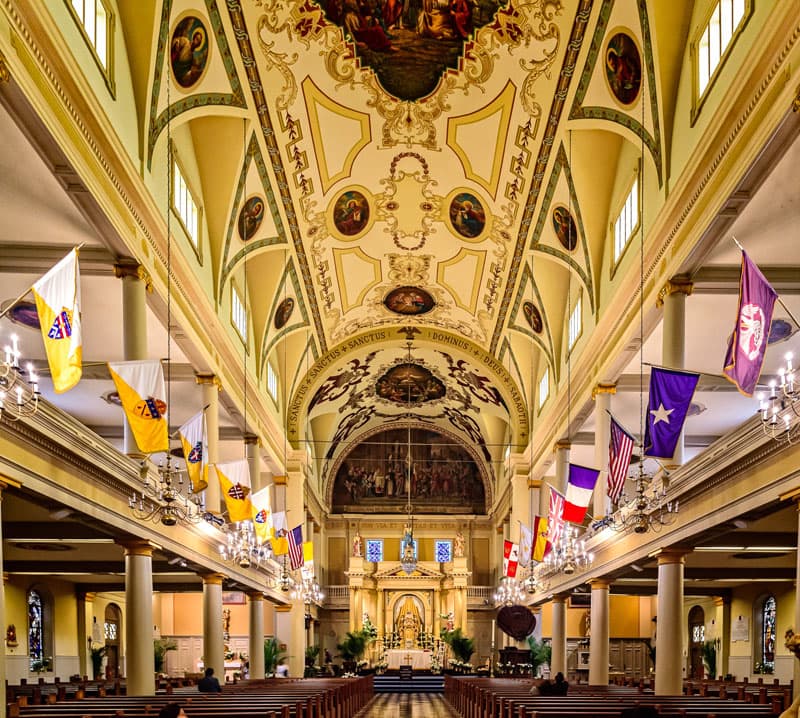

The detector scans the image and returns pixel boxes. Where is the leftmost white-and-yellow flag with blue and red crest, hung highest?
[32,248,82,394]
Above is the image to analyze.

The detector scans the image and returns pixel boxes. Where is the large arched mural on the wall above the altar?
[333,429,486,514]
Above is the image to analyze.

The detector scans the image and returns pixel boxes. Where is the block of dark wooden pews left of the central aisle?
[7,676,375,718]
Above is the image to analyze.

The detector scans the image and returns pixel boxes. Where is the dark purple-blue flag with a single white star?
[644,367,700,459]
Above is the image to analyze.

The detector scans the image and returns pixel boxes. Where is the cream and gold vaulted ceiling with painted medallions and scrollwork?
[146,0,663,505]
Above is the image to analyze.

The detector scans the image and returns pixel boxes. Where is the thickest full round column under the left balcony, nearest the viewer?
[119,540,155,696]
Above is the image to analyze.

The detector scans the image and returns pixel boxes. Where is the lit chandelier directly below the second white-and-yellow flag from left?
[128,459,209,526]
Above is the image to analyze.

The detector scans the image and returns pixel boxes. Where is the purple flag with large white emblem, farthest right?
[722,252,778,396]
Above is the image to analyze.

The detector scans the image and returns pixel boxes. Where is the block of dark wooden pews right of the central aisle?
[444,676,791,718]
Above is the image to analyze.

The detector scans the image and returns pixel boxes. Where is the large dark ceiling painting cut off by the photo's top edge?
[318,0,500,100]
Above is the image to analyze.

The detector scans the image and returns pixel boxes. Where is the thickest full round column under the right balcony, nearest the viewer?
[655,549,687,696]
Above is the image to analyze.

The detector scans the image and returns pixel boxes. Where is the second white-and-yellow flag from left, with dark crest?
[108,359,169,454]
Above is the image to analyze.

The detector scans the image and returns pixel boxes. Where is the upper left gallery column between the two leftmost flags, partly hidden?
[114,259,153,458]
